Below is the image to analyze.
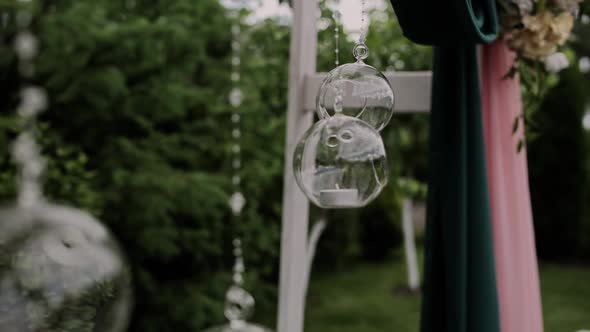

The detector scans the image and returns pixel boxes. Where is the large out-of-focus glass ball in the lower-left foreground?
[0,203,131,332]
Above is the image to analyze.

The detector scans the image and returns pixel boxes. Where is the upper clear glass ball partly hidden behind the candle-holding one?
[316,44,395,131]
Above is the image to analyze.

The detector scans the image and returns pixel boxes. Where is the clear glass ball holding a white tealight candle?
[293,113,389,208]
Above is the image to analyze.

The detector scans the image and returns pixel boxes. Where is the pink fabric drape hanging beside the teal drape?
[481,40,543,332]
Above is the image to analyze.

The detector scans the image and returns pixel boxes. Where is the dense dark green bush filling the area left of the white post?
[0,0,288,332]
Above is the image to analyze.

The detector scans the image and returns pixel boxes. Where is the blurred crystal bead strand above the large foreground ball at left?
[12,0,48,207]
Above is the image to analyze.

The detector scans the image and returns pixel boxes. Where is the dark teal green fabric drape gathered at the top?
[392,0,500,332]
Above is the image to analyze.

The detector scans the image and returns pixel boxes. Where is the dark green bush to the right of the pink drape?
[528,67,587,259]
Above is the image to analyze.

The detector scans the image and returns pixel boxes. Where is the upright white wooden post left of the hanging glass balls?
[277,0,319,332]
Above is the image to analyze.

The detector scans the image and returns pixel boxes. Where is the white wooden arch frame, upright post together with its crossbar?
[277,0,431,332]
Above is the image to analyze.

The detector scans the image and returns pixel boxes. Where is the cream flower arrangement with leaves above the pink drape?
[498,0,590,150]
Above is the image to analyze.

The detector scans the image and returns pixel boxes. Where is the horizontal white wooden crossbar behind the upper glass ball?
[304,71,432,113]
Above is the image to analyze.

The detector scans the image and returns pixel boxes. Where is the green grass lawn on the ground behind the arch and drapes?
[305,262,590,332]
